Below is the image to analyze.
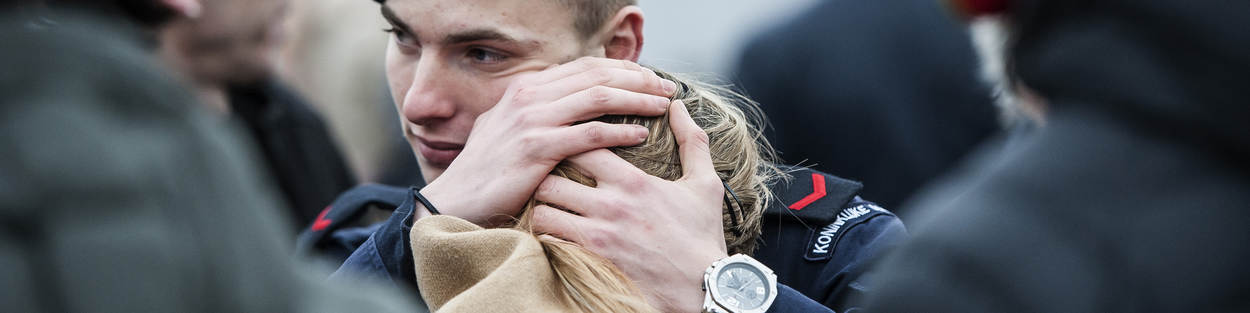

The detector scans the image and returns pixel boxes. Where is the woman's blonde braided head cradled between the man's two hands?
[542,69,780,254]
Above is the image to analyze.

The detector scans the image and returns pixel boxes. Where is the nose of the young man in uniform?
[403,60,456,125]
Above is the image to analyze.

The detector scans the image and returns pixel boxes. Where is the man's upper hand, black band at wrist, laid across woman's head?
[418,58,676,227]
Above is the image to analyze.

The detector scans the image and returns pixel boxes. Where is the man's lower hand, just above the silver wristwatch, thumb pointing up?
[534,101,729,312]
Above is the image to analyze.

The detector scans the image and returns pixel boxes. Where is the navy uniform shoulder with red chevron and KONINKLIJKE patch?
[755,167,906,312]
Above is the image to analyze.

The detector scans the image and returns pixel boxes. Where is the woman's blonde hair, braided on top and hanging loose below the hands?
[515,70,784,312]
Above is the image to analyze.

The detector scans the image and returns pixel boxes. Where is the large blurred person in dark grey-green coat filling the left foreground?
[0,0,413,312]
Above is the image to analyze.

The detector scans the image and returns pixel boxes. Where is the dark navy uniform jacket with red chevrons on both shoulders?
[299,168,906,313]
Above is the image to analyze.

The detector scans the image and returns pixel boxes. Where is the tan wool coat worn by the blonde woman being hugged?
[411,215,578,312]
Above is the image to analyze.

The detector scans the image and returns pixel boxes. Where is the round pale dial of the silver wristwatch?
[716,263,771,309]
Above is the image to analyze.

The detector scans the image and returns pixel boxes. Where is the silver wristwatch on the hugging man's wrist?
[704,254,778,313]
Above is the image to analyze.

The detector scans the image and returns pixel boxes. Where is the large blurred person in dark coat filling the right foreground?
[870,0,1250,312]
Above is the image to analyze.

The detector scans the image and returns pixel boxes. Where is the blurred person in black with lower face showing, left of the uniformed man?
[160,0,356,227]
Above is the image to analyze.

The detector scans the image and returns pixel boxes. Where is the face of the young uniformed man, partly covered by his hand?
[383,0,590,182]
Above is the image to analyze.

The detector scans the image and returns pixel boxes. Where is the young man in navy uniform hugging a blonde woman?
[301,0,905,312]
